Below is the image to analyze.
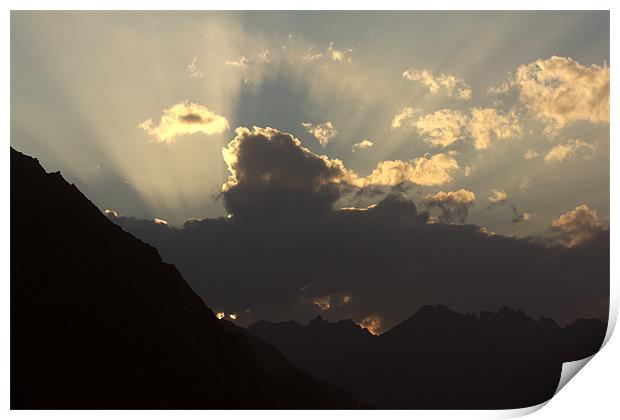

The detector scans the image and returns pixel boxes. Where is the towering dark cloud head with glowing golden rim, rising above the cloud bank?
[222,127,357,220]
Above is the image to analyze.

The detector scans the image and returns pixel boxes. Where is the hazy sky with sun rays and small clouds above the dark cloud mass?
[11,12,609,236]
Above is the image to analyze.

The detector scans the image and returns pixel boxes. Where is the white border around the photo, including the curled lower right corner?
[0,0,620,420]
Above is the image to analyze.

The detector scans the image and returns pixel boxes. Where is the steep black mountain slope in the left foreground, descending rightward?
[11,148,358,409]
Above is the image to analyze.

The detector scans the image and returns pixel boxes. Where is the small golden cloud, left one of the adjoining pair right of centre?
[415,109,467,147]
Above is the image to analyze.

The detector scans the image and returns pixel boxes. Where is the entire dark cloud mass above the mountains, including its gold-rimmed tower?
[108,127,609,329]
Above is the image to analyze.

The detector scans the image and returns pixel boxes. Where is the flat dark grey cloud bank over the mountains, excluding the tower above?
[109,202,609,334]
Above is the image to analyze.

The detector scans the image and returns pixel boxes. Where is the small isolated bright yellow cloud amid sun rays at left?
[138,102,228,144]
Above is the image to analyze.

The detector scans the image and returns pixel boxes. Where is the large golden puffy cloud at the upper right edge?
[490,56,609,137]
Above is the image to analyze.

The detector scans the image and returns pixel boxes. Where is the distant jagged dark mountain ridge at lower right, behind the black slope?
[248,305,606,409]
